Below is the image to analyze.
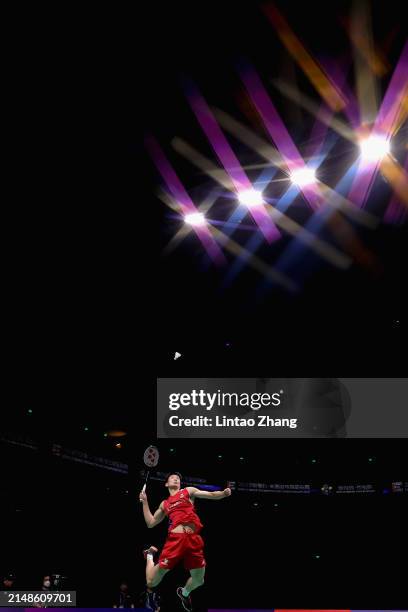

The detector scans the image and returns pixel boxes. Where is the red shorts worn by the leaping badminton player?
[159,532,205,570]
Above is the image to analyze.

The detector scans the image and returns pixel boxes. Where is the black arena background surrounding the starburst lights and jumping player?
[0,2,407,609]
